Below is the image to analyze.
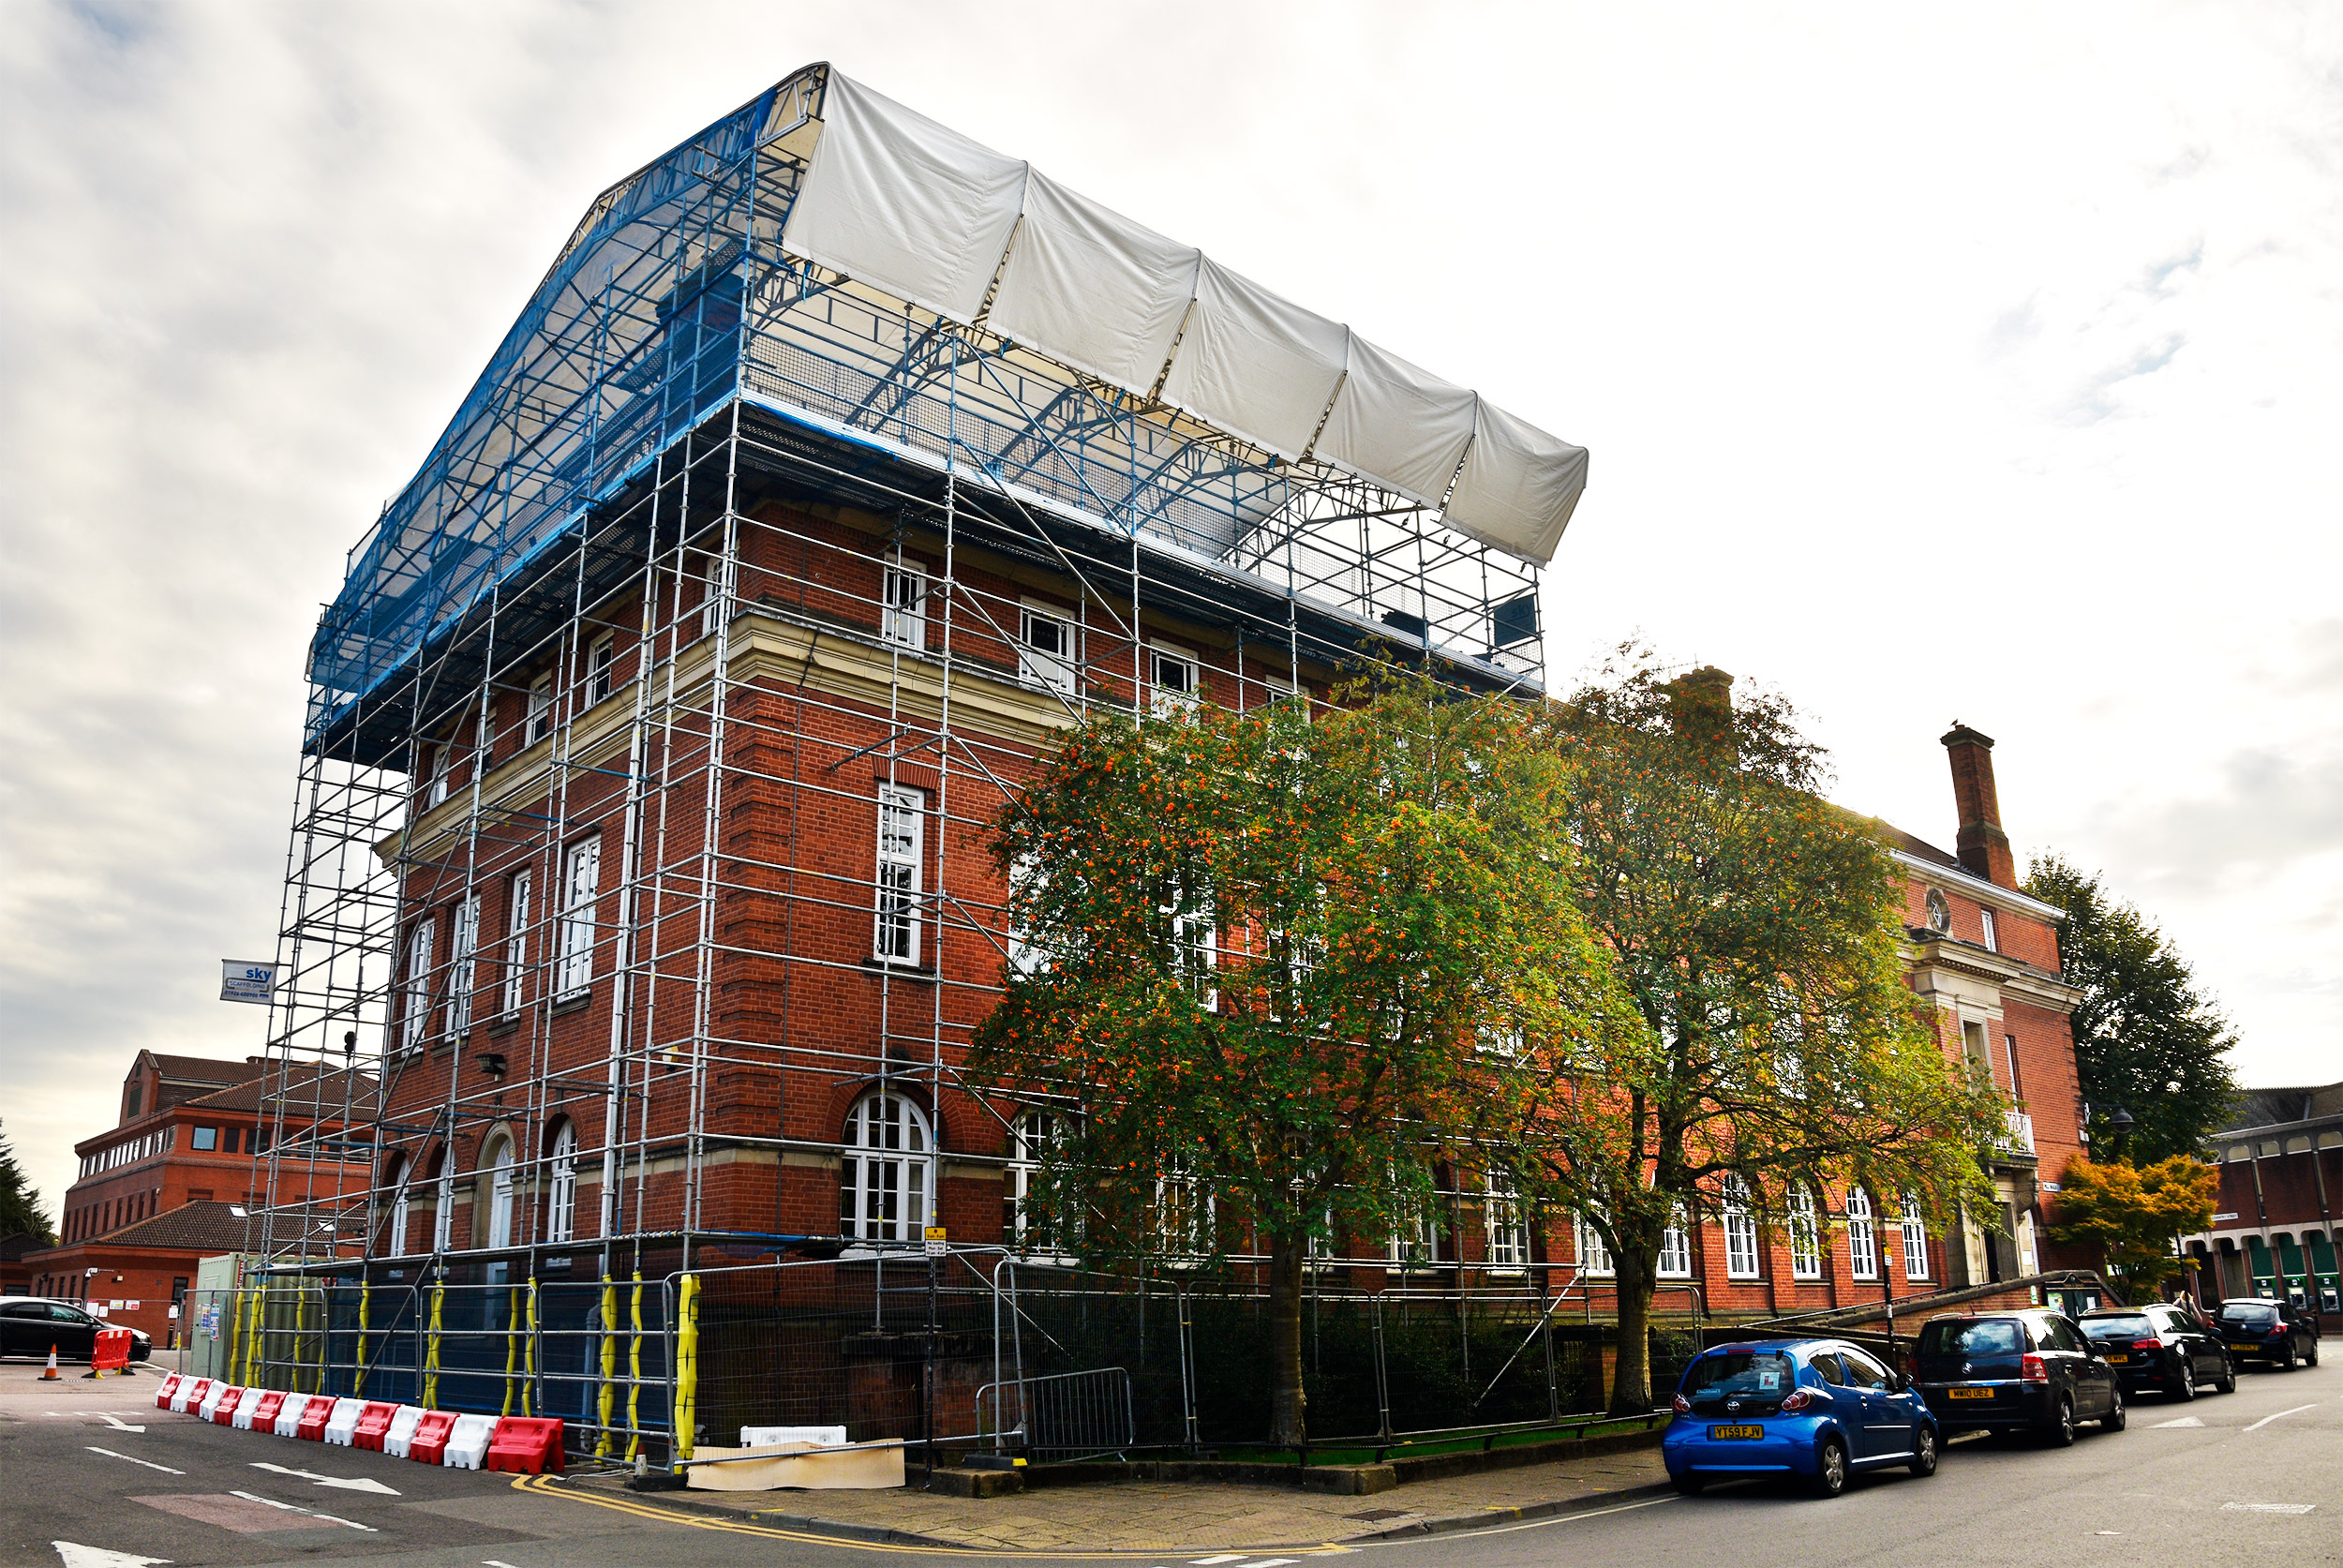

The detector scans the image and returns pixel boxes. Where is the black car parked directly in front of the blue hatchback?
[1910,1310,2123,1446]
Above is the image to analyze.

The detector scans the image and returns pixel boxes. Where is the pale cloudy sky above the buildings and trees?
[0,0,2343,1214]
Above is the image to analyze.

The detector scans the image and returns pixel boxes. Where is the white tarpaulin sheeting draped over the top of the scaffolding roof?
[781,70,1587,562]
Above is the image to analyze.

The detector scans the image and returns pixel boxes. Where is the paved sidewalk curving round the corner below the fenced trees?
[575,1448,1668,1551]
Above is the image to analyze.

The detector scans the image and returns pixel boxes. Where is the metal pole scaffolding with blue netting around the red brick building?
[251,66,1545,1443]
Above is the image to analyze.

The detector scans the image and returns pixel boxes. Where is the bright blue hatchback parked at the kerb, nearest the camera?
[1659,1338,1945,1498]
